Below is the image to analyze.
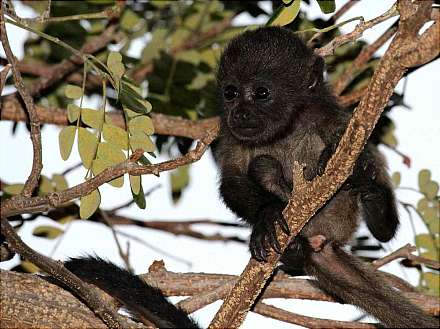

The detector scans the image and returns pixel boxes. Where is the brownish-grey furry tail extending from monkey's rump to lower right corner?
[305,242,440,328]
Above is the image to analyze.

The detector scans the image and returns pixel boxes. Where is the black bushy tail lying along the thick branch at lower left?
[64,256,198,328]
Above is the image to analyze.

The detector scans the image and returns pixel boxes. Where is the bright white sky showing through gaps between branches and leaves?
[0,0,440,329]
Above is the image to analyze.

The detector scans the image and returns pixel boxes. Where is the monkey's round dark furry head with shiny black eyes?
[217,27,324,145]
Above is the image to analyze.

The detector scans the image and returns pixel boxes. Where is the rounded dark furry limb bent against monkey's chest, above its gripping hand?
[248,155,292,202]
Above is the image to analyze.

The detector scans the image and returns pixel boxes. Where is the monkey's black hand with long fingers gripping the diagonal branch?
[249,203,290,261]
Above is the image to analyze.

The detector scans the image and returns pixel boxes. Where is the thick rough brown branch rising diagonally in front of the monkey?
[210,0,431,328]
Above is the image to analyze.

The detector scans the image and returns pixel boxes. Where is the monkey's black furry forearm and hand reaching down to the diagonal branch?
[220,167,289,261]
